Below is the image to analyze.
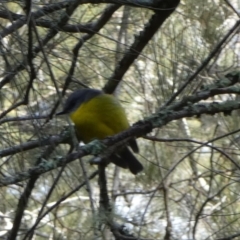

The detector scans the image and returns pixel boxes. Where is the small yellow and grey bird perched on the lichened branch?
[56,88,143,175]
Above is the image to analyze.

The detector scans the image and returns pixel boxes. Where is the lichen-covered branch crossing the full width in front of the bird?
[0,96,240,186]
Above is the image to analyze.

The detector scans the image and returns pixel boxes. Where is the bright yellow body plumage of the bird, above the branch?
[70,94,129,143]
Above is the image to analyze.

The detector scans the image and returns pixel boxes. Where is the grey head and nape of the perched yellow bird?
[56,88,103,115]
